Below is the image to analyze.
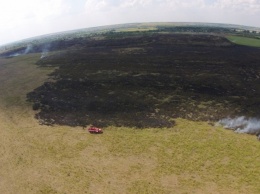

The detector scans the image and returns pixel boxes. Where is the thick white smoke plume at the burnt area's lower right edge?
[219,116,260,136]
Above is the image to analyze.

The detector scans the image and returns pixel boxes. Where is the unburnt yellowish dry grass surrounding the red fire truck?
[0,55,260,194]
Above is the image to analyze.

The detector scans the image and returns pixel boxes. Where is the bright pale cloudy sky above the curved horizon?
[0,0,260,45]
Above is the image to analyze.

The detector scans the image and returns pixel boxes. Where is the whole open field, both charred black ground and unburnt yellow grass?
[0,27,260,194]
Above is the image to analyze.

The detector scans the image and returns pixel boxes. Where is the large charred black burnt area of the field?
[27,33,260,128]
